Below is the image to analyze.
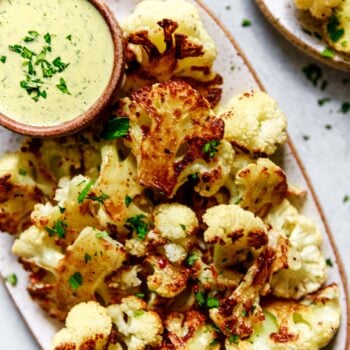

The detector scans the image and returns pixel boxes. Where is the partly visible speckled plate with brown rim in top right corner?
[255,0,350,71]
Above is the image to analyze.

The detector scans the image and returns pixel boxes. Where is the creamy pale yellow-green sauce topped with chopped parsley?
[0,0,114,126]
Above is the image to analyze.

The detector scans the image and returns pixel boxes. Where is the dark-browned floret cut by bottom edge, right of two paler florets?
[163,310,220,350]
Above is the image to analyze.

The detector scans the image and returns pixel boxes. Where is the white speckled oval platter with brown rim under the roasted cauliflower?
[0,0,350,350]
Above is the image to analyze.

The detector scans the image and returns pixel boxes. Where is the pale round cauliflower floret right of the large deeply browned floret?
[219,91,287,155]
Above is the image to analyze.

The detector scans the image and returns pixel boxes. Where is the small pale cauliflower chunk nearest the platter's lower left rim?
[12,226,64,272]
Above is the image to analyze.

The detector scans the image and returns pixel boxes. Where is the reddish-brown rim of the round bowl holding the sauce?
[0,0,124,137]
